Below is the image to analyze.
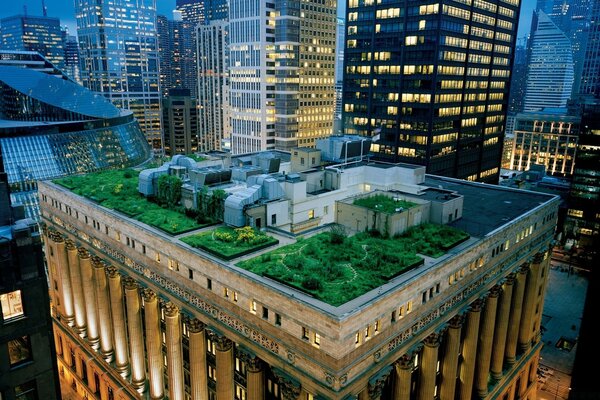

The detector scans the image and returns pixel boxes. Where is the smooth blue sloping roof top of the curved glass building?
[0,66,120,118]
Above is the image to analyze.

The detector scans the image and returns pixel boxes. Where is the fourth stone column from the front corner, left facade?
[188,319,208,400]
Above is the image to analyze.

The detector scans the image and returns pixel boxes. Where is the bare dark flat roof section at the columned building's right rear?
[425,175,556,237]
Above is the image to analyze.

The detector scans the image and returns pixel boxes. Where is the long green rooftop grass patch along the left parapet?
[53,169,206,235]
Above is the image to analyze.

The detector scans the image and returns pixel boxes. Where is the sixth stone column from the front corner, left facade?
[143,289,165,399]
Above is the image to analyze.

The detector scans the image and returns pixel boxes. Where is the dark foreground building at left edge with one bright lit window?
[0,168,61,400]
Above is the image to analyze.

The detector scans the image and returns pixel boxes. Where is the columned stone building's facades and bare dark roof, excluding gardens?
[39,167,559,400]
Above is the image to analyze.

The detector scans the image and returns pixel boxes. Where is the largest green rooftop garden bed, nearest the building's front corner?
[237,224,469,306]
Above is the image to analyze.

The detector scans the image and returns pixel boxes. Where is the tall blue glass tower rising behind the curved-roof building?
[75,0,162,151]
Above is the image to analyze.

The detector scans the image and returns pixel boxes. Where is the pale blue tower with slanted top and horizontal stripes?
[523,11,574,111]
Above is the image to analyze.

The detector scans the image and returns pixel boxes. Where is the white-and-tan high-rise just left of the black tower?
[229,0,337,154]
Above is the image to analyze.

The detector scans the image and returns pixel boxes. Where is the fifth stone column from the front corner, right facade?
[458,299,483,400]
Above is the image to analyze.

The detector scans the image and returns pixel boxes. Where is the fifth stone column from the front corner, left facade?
[165,303,184,400]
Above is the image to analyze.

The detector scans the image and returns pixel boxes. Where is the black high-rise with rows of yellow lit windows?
[343,0,520,182]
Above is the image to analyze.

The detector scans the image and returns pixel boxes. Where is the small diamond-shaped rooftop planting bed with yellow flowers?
[181,226,279,260]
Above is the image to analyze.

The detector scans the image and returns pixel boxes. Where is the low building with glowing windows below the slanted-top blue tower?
[510,111,581,177]
